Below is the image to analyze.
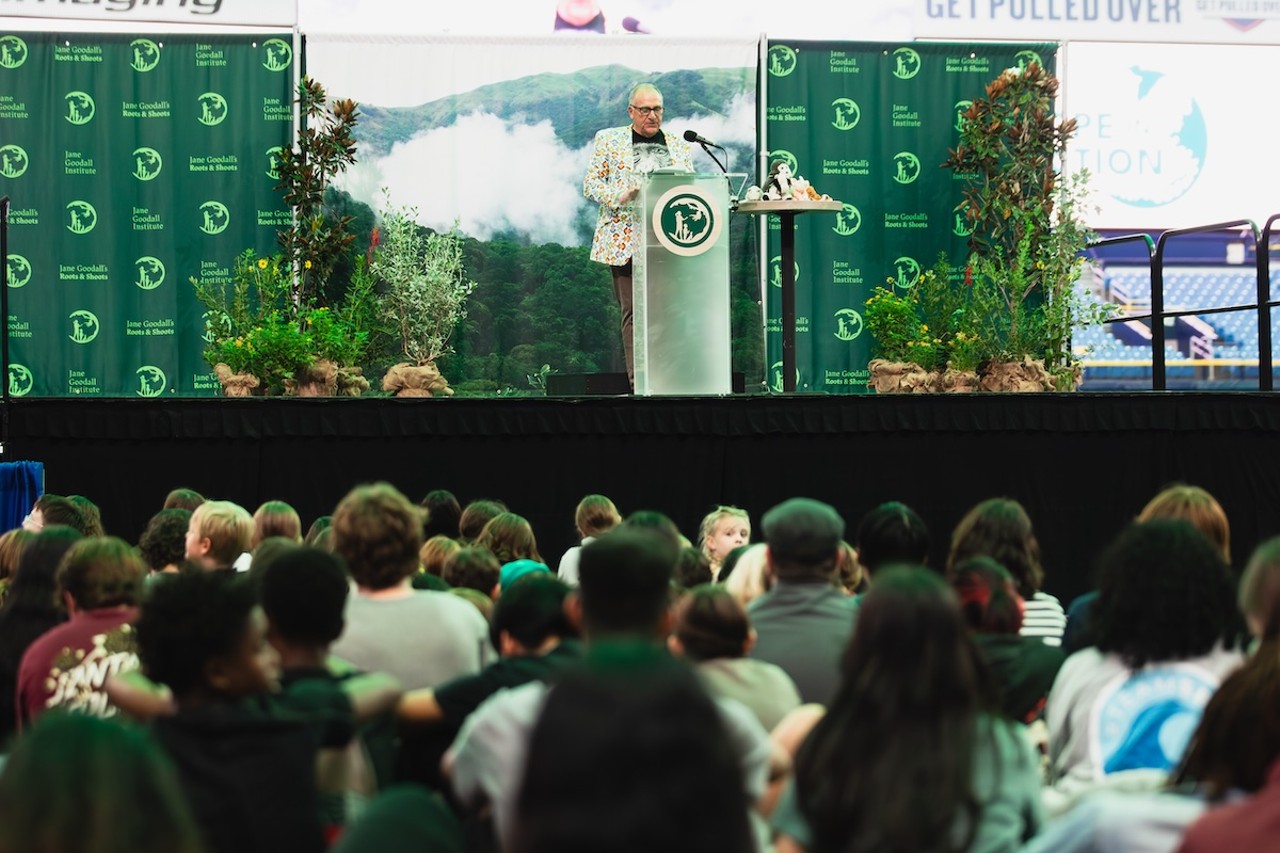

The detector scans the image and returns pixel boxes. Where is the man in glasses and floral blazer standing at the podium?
[582,83,694,391]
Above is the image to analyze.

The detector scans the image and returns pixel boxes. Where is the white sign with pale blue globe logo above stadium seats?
[1064,42,1280,229]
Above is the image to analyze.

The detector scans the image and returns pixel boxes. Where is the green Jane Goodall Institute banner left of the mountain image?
[0,32,294,397]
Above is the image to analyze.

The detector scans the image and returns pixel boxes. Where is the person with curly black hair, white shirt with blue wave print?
[1046,519,1242,795]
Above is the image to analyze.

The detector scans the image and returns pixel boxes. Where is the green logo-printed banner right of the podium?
[764,41,1057,393]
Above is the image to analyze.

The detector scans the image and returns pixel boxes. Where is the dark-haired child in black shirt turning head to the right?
[137,563,355,853]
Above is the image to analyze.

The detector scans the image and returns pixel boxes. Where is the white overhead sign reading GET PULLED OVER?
[913,0,1280,45]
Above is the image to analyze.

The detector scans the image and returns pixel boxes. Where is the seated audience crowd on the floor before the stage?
[0,483,1280,853]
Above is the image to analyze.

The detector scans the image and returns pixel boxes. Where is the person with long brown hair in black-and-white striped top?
[947,498,1066,646]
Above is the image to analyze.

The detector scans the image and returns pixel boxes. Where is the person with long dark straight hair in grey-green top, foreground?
[773,567,1043,853]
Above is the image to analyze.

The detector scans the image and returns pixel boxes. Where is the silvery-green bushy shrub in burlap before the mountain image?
[370,206,475,397]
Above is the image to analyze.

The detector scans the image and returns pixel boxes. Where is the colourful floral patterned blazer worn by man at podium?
[582,124,694,266]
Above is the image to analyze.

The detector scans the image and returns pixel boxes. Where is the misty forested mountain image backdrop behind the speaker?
[328,65,764,394]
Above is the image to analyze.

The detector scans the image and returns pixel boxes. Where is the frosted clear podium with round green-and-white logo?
[632,172,732,396]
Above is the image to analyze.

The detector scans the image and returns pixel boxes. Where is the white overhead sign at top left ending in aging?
[0,0,298,27]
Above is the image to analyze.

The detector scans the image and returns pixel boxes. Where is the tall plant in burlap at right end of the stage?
[942,63,1110,391]
